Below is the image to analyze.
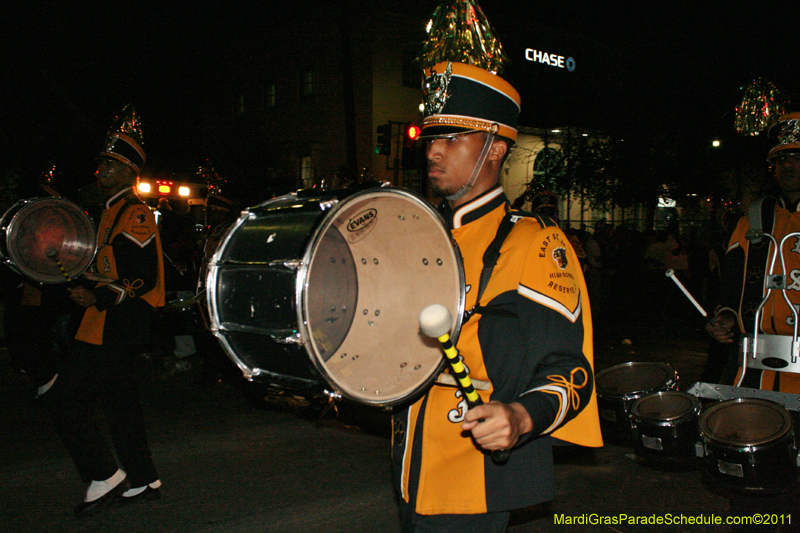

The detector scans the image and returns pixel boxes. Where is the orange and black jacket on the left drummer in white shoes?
[75,188,164,345]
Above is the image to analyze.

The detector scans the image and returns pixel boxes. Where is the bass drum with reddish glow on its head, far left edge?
[0,198,97,283]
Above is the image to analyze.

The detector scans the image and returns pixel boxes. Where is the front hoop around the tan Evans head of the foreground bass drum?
[295,187,466,405]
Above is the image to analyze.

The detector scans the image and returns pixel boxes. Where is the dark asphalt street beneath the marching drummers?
[0,320,788,533]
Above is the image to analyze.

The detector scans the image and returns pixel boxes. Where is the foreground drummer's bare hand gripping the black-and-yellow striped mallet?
[461,402,533,450]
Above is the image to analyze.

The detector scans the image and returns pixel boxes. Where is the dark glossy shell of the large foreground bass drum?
[211,195,348,396]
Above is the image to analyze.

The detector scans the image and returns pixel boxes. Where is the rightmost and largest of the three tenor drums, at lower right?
[700,398,797,493]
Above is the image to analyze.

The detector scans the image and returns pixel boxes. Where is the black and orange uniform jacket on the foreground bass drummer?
[393,186,602,515]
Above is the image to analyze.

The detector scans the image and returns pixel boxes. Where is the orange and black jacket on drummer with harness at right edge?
[716,197,800,394]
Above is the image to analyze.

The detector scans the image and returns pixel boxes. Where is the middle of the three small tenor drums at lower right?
[631,391,702,462]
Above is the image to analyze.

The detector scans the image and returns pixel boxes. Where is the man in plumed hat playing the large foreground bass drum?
[393,63,602,533]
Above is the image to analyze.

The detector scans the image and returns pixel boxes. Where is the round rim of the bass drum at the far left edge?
[0,196,97,284]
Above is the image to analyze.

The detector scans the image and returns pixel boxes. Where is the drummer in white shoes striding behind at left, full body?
[42,106,164,517]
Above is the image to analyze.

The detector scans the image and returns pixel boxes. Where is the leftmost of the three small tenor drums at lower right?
[595,363,678,439]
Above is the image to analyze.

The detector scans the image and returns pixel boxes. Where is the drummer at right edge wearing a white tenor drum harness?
[706,113,800,394]
